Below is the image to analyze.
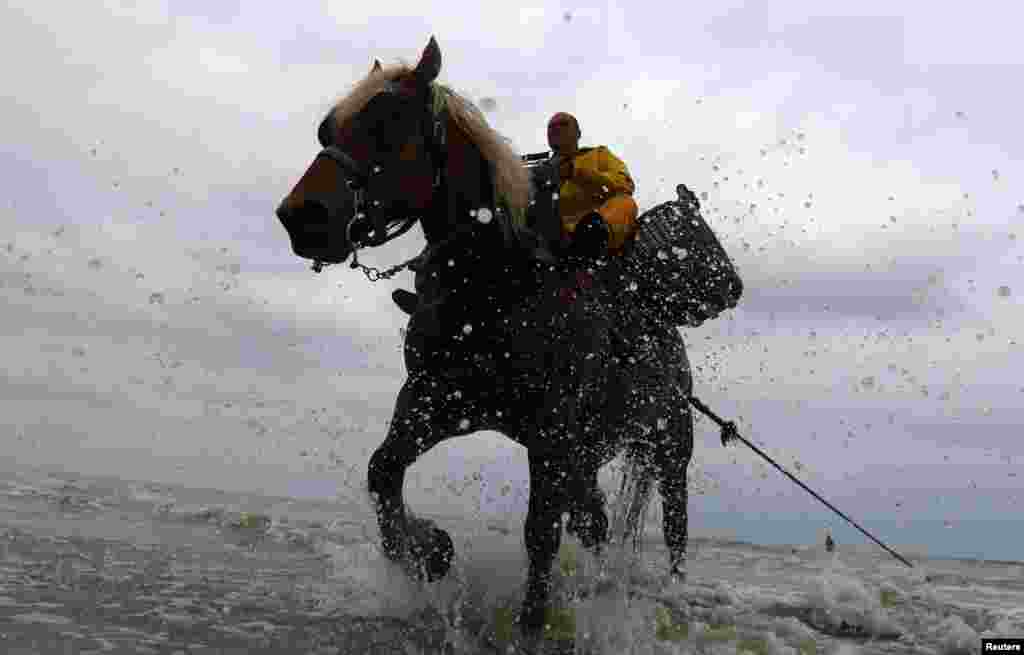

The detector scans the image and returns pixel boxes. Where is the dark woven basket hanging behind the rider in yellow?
[624,202,743,326]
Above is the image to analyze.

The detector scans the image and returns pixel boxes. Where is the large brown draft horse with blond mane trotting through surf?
[276,37,708,636]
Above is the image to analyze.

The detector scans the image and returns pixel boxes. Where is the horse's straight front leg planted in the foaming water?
[519,453,571,637]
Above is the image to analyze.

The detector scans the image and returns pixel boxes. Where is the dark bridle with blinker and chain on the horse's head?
[312,81,447,274]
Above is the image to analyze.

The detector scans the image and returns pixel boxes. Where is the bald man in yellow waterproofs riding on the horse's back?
[548,112,638,257]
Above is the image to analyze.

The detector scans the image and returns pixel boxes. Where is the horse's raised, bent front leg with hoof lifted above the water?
[367,379,458,581]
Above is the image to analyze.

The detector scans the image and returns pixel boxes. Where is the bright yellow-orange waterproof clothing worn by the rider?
[558,145,638,254]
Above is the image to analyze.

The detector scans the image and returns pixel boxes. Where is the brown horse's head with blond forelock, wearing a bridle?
[276,37,443,263]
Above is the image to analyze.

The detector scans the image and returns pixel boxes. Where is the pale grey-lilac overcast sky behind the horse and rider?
[0,0,1024,560]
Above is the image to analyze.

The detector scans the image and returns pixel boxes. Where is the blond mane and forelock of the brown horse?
[332,63,530,227]
